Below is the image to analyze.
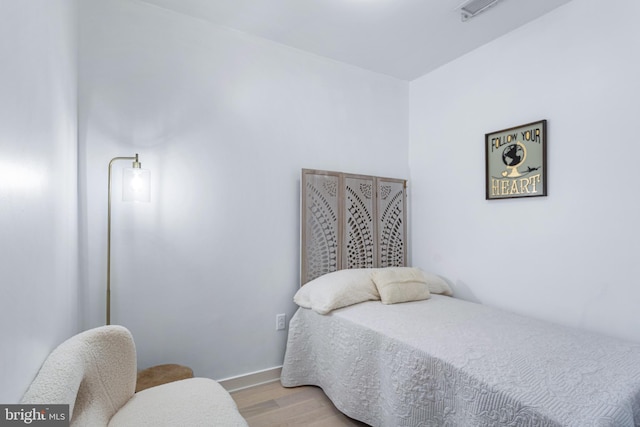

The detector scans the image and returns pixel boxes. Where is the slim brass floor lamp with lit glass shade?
[107,154,151,325]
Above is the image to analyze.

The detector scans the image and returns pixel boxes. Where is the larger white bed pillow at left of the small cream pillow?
[293,268,380,314]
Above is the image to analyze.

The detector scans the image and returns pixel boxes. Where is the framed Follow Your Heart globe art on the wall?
[485,120,548,200]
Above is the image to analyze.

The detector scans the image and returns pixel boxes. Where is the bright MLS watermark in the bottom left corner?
[0,404,69,427]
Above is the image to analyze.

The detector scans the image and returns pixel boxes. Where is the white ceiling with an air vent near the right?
[141,0,571,81]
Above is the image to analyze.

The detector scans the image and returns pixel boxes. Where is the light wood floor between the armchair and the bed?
[231,381,366,427]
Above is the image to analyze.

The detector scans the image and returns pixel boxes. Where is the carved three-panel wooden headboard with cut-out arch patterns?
[300,169,407,284]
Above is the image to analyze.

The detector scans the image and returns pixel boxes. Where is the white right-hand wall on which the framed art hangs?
[409,0,640,341]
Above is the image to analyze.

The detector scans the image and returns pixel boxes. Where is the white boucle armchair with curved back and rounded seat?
[22,326,247,427]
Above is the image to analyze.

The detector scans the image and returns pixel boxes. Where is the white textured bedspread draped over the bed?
[282,295,640,427]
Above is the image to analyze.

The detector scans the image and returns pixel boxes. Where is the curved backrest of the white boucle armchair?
[22,325,136,427]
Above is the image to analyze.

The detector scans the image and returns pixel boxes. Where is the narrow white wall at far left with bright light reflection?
[0,0,80,403]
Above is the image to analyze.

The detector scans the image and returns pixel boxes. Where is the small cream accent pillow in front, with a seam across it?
[371,267,431,304]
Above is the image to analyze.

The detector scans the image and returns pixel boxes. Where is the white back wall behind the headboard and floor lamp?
[79,0,409,379]
